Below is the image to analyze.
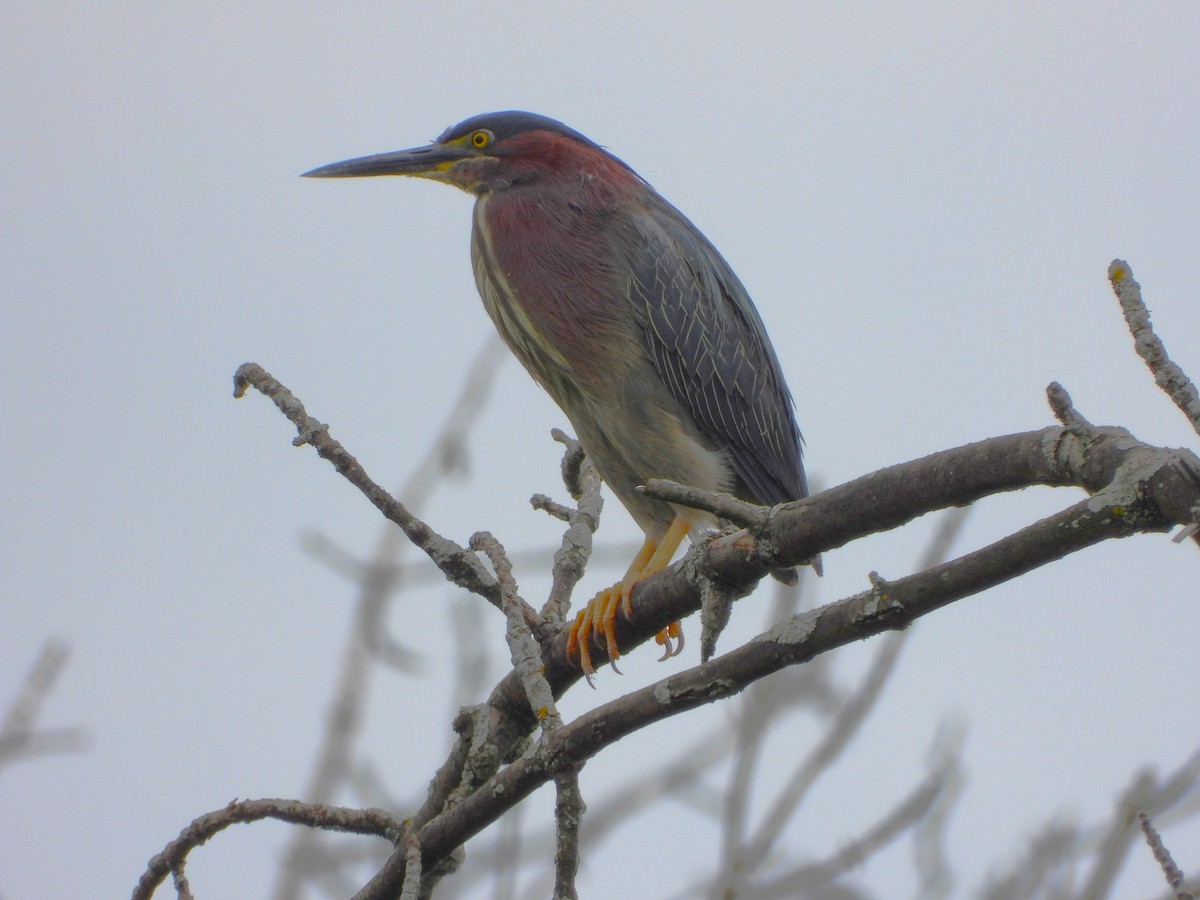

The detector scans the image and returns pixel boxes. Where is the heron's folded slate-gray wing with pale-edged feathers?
[630,198,808,504]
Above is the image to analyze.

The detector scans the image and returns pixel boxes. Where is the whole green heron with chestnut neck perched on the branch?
[305,112,808,680]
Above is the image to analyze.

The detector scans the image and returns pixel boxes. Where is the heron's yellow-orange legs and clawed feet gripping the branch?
[566,516,691,684]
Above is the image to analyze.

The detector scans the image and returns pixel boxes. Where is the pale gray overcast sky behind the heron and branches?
[0,2,1200,900]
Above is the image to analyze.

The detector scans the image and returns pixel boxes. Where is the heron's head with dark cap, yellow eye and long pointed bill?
[304,110,637,194]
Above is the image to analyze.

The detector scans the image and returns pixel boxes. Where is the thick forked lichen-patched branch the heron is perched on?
[348,417,1200,899]
